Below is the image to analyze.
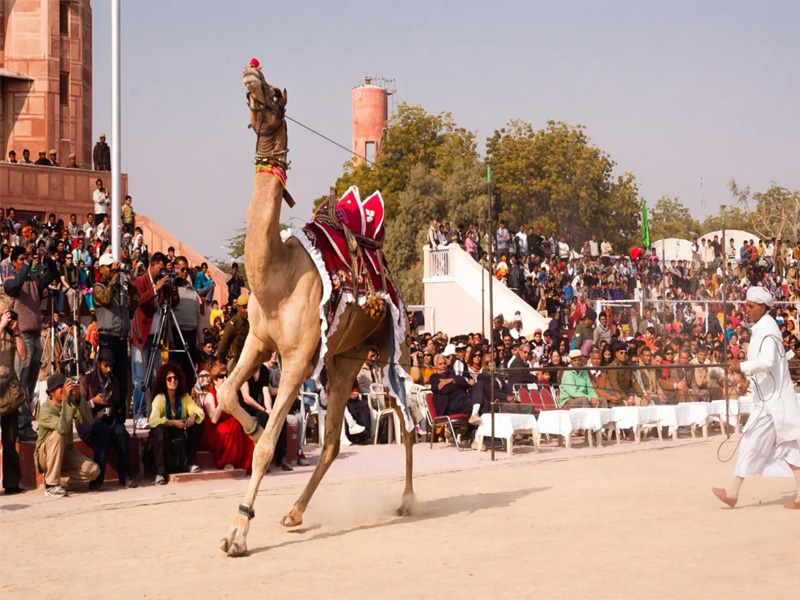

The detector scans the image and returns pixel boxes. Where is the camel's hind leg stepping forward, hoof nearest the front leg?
[281,346,368,527]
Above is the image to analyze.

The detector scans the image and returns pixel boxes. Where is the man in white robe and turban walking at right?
[712,286,800,509]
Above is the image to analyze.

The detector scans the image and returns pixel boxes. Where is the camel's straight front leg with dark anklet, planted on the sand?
[220,356,308,556]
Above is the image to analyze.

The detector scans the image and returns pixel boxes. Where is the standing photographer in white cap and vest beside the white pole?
[92,254,139,406]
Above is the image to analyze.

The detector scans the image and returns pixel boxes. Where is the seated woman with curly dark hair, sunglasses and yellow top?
[144,362,205,485]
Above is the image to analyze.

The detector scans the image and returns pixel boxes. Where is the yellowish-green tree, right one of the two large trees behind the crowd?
[487,120,640,248]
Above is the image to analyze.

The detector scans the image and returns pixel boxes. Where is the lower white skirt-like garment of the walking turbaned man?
[733,409,800,477]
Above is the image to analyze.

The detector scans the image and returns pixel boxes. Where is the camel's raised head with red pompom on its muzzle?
[242,58,289,168]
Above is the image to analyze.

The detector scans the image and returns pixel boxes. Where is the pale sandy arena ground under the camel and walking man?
[0,435,800,600]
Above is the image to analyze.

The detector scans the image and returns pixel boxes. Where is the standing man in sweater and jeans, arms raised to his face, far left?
[3,246,58,440]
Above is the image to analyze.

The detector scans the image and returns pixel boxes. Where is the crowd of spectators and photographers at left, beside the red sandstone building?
[0,202,308,497]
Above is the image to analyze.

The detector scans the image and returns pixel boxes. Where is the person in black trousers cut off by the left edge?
[0,295,27,496]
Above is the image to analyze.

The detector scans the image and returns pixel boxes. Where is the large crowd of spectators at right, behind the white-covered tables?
[416,221,800,422]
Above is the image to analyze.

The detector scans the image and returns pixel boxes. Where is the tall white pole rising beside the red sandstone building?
[110,0,122,260]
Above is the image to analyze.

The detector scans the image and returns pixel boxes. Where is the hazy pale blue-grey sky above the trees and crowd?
[92,0,800,257]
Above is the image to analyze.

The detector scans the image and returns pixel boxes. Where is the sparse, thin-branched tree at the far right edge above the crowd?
[728,179,800,240]
